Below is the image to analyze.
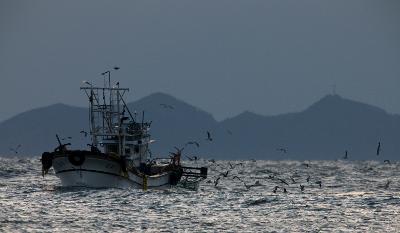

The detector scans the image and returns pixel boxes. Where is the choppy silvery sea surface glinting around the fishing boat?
[0,158,400,232]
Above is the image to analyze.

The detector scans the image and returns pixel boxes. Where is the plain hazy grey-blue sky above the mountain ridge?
[0,0,400,120]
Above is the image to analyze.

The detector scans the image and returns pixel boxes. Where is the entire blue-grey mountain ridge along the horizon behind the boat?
[0,93,400,160]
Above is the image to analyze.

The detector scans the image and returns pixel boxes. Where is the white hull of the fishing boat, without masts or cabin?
[53,155,171,189]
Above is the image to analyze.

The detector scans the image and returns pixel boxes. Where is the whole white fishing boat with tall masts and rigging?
[41,72,207,190]
